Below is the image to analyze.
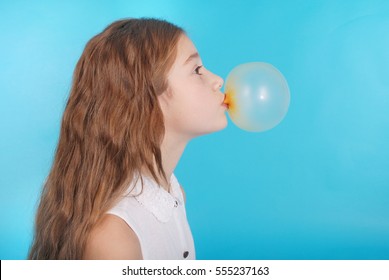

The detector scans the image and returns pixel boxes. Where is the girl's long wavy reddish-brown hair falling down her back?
[29,19,184,259]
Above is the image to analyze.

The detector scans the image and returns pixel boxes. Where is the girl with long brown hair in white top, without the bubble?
[29,19,227,259]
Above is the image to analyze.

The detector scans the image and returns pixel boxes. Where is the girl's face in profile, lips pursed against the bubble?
[160,35,227,140]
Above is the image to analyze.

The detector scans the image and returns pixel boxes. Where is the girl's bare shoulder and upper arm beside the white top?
[84,214,142,260]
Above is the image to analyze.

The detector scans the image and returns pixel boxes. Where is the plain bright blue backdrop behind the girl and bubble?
[0,0,389,259]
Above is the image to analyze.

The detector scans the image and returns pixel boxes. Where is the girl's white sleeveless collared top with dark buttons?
[107,175,196,260]
